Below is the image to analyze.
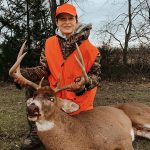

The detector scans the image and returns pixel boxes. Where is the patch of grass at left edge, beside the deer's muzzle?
[0,85,26,150]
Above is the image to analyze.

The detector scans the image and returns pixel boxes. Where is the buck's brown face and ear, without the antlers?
[27,86,79,121]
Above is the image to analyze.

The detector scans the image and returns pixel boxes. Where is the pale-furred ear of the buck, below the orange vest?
[57,98,80,113]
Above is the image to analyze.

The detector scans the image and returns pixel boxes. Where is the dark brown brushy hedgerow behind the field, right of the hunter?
[99,44,150,81]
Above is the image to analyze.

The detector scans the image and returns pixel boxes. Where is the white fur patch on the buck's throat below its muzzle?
[36,120,55,131]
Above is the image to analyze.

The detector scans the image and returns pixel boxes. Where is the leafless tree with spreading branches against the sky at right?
[98,0,150,65]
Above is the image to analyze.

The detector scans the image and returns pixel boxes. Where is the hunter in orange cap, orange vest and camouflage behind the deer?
[15,4,101,150]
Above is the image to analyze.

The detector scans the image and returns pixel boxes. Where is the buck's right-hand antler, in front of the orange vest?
[54,43,89,93]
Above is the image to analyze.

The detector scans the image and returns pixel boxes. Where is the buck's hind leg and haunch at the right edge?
[115,102,150,139]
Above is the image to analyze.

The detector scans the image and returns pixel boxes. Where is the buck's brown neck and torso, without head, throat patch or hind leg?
[34,98,133,150]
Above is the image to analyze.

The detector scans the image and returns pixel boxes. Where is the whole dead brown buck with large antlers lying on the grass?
[9,42,150,150]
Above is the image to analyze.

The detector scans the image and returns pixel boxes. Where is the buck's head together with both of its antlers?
[9,42,89,121]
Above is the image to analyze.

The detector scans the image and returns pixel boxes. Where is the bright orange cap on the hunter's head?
[56,3,77,16]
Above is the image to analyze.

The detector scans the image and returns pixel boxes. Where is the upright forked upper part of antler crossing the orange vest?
[74,43,89,83]
